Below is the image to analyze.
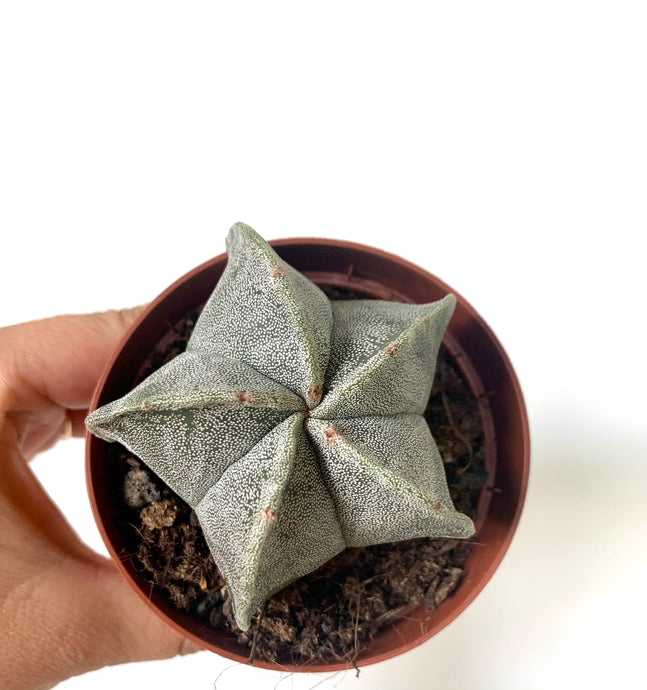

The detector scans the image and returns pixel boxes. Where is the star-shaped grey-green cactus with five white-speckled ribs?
[86,223,474,630]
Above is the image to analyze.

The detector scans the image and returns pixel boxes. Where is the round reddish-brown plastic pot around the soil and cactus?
[86,238,530,672]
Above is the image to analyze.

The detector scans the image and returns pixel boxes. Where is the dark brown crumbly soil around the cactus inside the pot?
[110,288,486,664]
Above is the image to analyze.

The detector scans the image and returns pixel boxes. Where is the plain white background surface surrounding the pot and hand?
[0,0,647,690]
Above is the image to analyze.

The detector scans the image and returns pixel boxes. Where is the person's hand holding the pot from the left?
[0,308,198,690]
